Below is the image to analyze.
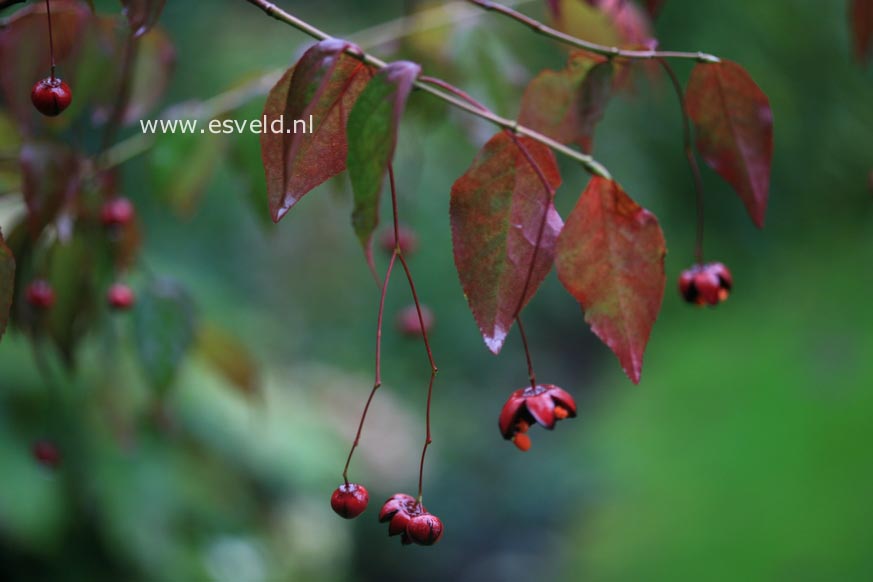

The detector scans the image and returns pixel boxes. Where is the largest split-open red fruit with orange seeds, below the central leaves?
[498,384,576,451]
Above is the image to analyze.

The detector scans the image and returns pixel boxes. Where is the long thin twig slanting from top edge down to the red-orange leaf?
[246,0,612,180]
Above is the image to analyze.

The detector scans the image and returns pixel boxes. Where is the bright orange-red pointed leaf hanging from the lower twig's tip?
[555,177,667,383]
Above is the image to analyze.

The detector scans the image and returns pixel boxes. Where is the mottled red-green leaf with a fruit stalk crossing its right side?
[450,131,563,354]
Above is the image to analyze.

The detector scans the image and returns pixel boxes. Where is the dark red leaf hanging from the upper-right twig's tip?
[685,61,773,227]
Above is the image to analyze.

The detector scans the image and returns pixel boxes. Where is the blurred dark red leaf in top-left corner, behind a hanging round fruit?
[0,0,91,130]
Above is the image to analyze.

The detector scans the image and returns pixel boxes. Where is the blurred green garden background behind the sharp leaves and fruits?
[0,0,873,582]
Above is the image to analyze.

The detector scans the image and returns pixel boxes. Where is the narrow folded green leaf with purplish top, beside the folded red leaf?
[348,61,421,267]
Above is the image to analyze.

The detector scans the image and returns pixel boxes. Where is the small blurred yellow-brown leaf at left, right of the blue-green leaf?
[196,323,261,397]
